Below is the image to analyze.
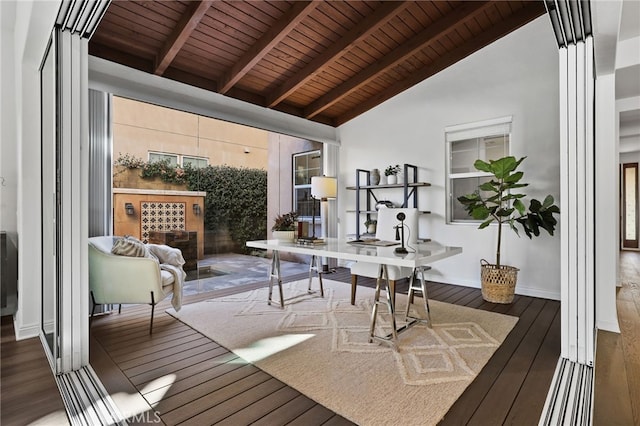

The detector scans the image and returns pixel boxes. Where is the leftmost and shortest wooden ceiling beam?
[153,0,214,75]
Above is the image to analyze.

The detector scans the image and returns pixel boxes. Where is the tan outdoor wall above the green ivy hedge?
[113,96,268,170]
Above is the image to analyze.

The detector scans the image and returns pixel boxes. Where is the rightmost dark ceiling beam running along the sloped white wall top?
[336,2,545,126]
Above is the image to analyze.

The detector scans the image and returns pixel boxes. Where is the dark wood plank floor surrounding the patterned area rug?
[91,268,560,425]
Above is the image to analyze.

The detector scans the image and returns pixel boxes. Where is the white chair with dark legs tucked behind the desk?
[351,208,418,305]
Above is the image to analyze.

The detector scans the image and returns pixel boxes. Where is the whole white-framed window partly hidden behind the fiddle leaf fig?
[445,116,512,223]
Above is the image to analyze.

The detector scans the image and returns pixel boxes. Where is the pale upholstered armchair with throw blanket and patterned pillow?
[89,236,184,334]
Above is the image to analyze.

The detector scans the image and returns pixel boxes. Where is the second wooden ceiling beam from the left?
[219,0,320,94]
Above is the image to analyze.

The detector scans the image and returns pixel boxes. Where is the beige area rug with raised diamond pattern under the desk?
[167,279,518,425]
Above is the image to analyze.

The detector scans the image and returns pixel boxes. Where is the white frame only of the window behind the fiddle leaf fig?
[444,116,513,225]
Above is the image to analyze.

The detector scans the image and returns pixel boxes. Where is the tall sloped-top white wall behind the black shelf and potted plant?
[338,15,560,299]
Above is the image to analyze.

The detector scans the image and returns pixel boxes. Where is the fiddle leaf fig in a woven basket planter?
[458,156,560,303]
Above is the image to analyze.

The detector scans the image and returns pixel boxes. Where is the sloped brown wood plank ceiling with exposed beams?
[89,0,545,126]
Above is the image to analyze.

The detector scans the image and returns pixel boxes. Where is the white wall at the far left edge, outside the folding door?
[0,0,60,339]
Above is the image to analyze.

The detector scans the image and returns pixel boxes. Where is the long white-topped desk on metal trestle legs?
[247,238,462,343]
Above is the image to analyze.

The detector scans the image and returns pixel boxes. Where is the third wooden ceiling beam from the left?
[267,1,409,108]
